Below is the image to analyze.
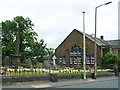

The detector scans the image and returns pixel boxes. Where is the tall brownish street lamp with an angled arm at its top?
[94,2,112,79]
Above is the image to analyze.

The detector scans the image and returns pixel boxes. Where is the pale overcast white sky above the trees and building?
[0,0,119,49]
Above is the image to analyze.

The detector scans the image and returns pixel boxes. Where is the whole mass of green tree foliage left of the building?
[2,16,54,65]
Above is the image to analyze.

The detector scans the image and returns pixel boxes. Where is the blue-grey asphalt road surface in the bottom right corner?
[60,80,118,88]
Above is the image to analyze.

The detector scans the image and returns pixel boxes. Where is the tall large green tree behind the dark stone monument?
[2,16,37,62]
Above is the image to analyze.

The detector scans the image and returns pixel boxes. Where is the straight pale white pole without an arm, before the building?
[83,11,86,79]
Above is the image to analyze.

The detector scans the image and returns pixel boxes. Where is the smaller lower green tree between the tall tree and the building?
[29,39,55,62]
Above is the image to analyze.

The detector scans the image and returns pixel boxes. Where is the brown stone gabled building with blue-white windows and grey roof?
[55,29,117,68]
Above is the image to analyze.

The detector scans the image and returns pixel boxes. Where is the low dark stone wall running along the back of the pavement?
[2,73,115,85]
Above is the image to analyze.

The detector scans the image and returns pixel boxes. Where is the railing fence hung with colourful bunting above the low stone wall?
[1,68,114,76]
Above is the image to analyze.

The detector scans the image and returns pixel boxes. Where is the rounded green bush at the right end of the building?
[102,52,118,65]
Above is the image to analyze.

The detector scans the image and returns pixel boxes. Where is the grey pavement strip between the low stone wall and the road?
[2,76,118,88]
